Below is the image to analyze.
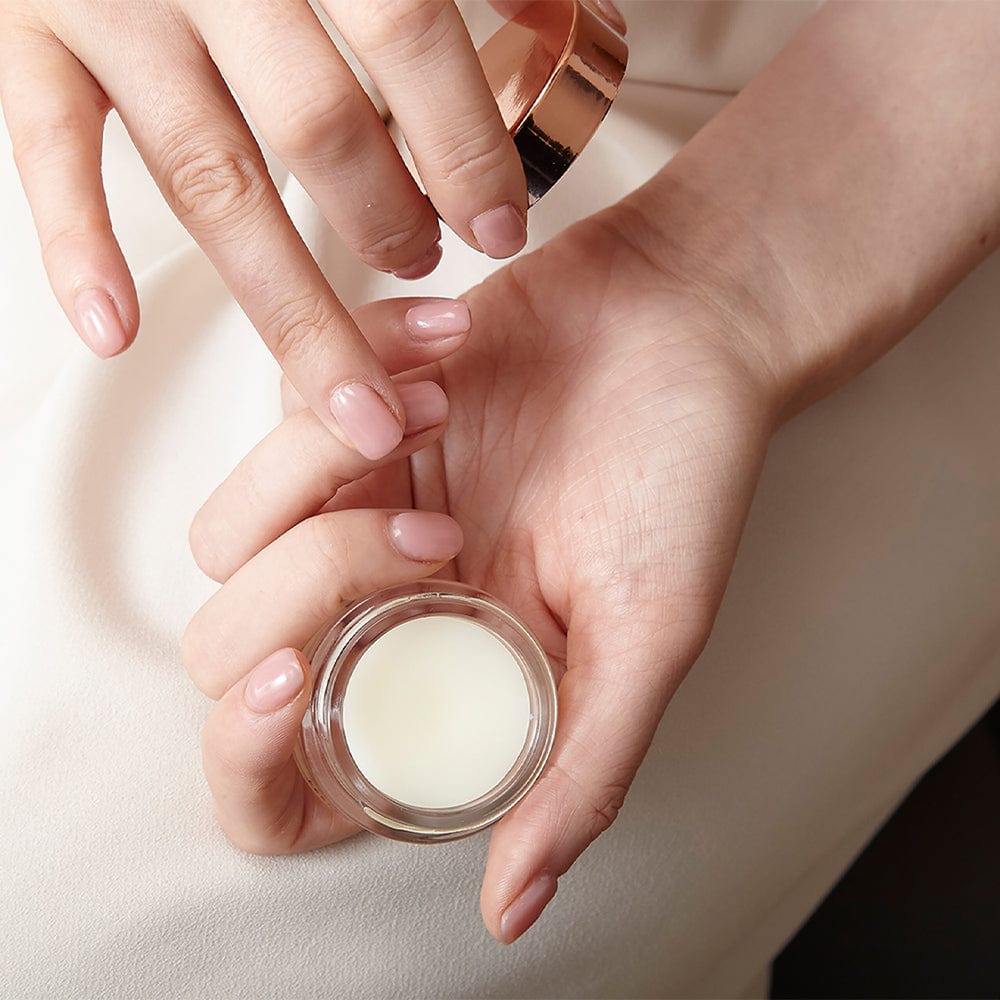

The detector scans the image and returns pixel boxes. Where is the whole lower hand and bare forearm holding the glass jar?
[185,4,1000,942]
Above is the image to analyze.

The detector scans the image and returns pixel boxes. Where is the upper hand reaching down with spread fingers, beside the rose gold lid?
[0,0,527,458]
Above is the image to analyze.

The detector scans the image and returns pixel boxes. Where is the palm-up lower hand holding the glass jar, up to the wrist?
[184,195,781,942]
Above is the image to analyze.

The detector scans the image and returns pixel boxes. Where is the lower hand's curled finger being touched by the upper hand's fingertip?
[190,382,448,582]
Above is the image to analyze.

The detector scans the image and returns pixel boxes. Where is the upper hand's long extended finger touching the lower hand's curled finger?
[69,23,403,459]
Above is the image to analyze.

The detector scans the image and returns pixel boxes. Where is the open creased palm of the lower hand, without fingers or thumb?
[411,214,768,680]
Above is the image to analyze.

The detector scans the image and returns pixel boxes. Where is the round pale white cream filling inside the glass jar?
[343,615,531,809]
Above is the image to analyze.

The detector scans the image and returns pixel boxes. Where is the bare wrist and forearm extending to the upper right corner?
[622,3,1000,419]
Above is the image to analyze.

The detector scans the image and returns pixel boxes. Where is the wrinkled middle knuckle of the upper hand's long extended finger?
[162,140,268,226]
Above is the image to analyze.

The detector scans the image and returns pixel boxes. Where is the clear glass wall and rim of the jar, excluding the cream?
[295,580,557,842]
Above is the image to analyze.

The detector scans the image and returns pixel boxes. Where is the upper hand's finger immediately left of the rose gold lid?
[323,0,528,258]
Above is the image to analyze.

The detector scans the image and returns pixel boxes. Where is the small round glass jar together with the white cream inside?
[295,580,556,842]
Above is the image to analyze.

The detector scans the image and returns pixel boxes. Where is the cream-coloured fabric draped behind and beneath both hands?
[0,3,1000,998]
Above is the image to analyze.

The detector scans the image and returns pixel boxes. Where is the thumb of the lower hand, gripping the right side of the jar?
[480,595,710,944]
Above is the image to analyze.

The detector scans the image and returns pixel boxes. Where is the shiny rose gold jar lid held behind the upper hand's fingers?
[479,0,628,205]
